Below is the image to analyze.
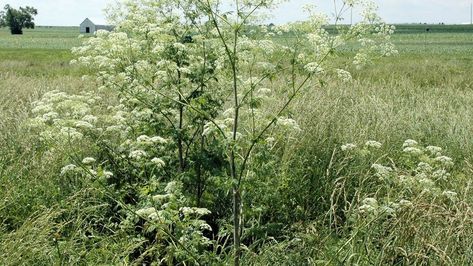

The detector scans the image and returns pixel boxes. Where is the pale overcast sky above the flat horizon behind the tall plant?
[0,0,473,26]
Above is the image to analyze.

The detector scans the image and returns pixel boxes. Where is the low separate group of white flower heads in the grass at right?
[344,139,458,225]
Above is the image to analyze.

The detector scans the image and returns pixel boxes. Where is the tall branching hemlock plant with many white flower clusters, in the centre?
[29,0,397,265]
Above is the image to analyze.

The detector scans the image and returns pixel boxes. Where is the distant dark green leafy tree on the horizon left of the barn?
[0,5,38,34]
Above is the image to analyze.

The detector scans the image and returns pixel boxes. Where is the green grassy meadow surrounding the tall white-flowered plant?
[0,21,473,265]
